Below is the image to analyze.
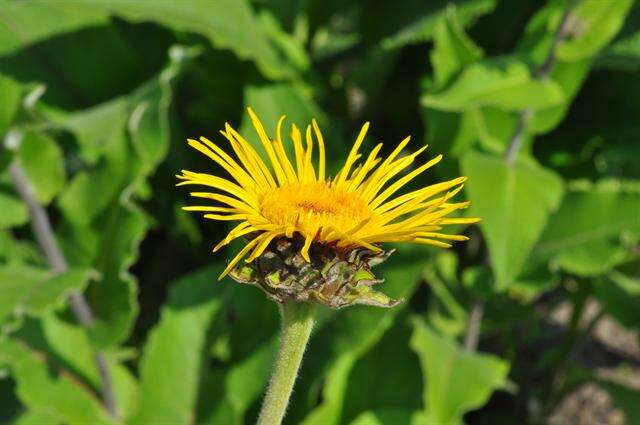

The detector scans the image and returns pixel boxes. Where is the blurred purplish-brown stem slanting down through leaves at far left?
[9,162,118,418]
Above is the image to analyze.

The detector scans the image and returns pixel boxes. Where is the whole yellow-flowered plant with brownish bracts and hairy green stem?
[177,108,479,424]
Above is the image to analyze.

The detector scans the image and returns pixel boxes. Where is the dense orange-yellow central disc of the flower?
[261,182,371,234]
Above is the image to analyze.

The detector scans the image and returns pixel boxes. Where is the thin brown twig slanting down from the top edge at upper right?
[504,1,573,165]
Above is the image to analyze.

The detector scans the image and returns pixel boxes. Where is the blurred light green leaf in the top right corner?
[557,0,634,62]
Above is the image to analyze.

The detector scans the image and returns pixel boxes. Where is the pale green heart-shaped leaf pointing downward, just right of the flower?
[461,152,564,289]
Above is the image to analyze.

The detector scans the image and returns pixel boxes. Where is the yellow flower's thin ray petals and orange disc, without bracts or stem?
[177,108,478,278]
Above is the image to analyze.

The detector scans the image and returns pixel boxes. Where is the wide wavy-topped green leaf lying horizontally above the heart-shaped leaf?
[421,60,564,111]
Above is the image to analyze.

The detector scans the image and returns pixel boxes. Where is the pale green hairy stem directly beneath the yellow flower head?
[258,301,314,425]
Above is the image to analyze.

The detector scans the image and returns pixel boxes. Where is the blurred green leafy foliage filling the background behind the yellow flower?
[0,0,640,425]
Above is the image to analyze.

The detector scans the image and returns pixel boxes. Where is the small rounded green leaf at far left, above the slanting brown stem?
[18,132,65,205]
